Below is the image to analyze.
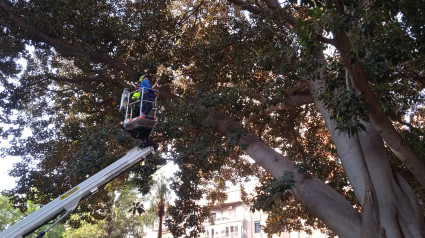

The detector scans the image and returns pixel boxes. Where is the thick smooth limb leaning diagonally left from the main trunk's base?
[209,109,362,238]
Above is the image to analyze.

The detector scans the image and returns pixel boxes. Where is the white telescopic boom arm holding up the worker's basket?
[0,147,155,238]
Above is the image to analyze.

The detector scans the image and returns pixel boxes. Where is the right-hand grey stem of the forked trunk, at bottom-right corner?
[359,123,425,238]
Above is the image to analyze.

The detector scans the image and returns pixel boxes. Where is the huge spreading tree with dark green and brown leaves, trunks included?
[0,0,425,237]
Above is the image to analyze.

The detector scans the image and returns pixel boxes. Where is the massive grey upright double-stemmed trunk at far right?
[310,49,424,238]
